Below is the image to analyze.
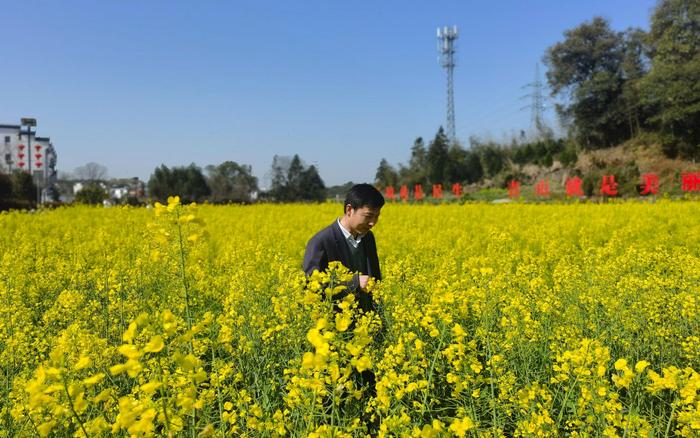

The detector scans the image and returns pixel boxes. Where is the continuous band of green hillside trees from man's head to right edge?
[375,0,700,192]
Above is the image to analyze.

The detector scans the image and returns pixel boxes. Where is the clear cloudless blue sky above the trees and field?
[0,0,656,185]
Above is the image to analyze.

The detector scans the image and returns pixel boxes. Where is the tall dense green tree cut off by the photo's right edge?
[641,0,700,158]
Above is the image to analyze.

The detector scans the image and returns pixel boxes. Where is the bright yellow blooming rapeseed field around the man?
[0,198,700,437]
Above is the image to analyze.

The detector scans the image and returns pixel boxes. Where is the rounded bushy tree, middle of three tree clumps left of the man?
[206,161,258,203]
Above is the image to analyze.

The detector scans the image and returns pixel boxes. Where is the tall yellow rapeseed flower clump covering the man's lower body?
[284,262,381,436]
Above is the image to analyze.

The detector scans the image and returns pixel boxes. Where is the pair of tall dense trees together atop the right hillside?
[544,0,700,158]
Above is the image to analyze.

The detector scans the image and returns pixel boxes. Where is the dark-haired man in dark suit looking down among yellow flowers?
[304,184,384,311]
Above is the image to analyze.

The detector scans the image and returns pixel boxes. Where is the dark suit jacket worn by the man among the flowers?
[303,220,382,310]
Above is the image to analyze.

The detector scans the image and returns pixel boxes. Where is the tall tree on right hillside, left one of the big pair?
[544,17,630,148]
